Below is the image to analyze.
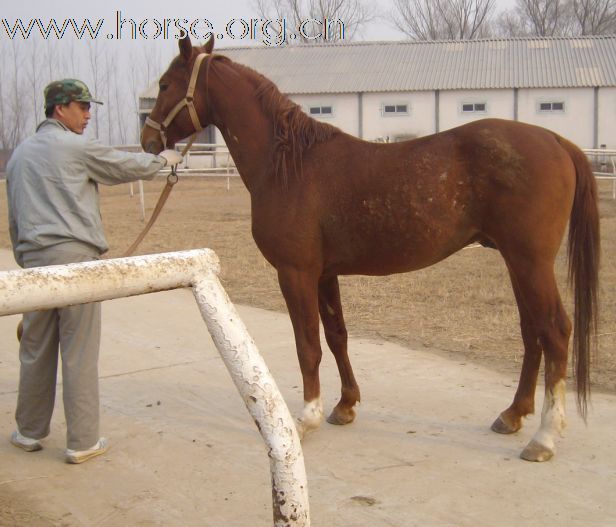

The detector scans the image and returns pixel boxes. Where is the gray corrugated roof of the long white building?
[142,35,616,97]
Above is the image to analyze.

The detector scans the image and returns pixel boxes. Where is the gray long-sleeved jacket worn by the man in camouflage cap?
[6,119,165,266]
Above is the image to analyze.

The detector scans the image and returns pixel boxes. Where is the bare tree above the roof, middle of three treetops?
[389,0,495,40]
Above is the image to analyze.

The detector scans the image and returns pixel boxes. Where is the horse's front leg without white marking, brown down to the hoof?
[319,276,359,425]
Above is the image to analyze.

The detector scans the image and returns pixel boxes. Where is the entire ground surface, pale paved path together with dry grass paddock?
[0,178,616,527]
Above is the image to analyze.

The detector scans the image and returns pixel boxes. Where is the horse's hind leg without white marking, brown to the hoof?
[492,273,541,434]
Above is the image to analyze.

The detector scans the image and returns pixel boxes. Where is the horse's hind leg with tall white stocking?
[500,255,571,461]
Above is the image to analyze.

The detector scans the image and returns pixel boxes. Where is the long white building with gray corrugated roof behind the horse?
[140,36,616,149]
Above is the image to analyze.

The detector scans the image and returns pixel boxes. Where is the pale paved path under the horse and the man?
[0,250,616,527]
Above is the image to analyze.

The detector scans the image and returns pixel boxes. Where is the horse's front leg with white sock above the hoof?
[278,268,323,437]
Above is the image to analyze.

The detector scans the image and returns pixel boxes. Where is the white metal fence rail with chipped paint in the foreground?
[0,249,310,527]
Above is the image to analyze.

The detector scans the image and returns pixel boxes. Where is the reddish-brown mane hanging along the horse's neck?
[216,56,340,186]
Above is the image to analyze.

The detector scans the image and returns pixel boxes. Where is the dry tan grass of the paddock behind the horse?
[0,178,616,391]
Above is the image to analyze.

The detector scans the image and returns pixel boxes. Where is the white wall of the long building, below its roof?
[203,83,616,149]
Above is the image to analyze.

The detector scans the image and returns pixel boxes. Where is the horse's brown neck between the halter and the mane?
[209,69,273,192]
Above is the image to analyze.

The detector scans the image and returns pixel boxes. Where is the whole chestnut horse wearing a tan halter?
[141,38,599,461]
